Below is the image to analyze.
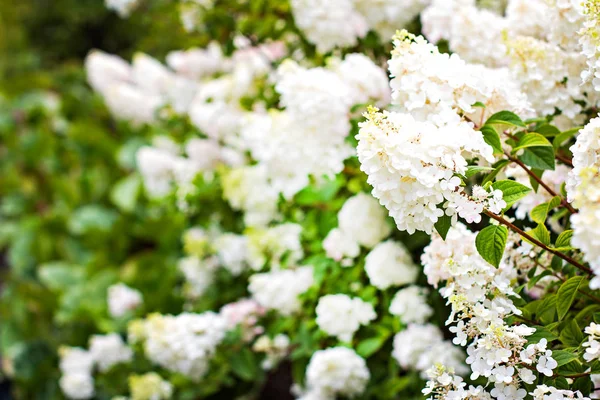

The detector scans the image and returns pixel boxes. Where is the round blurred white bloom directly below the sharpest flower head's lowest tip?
[365,240,418,290]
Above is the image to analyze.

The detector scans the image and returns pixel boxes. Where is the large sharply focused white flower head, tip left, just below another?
[357,109,505,234]
